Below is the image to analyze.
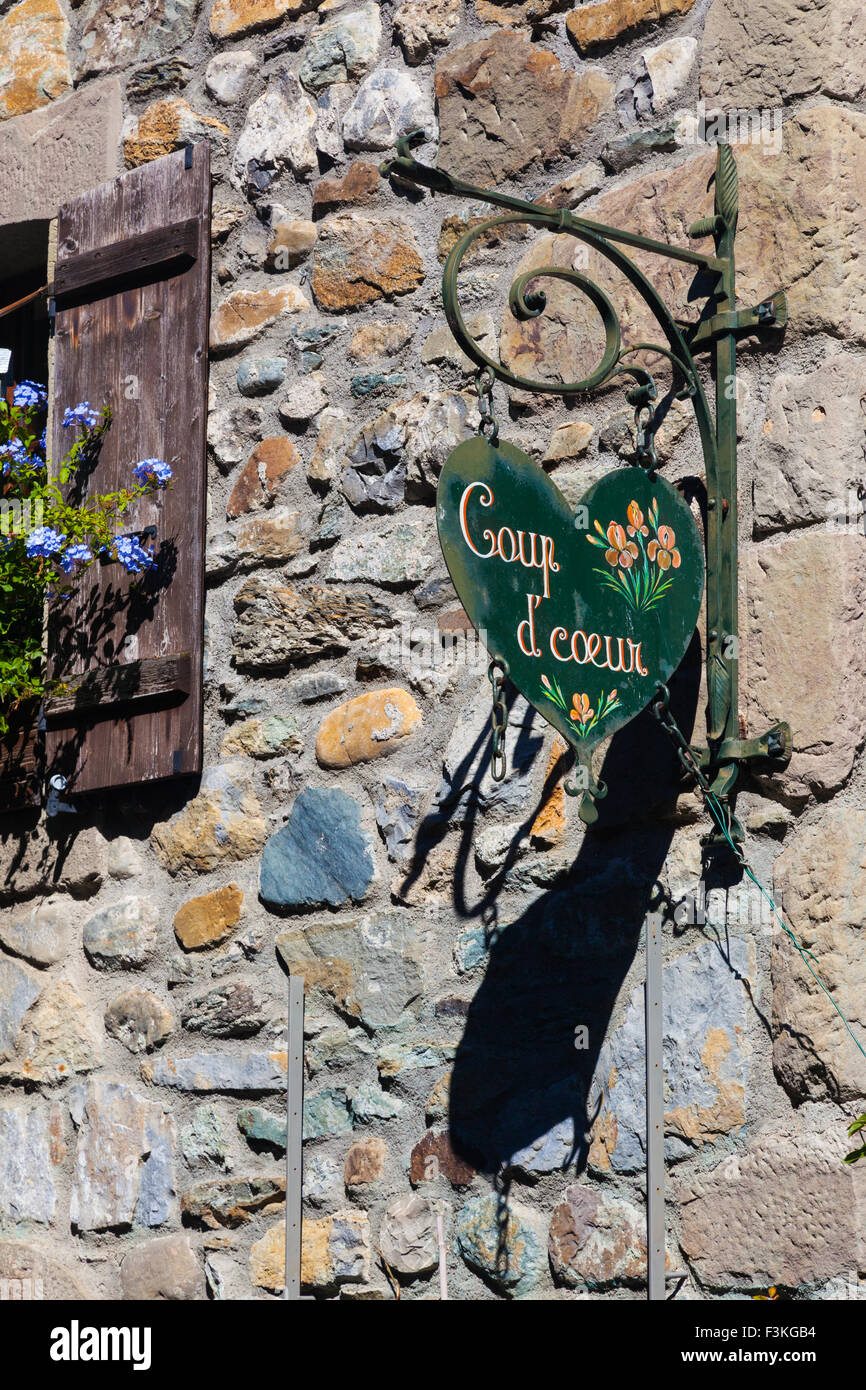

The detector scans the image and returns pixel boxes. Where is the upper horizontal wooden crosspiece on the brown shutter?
[54,217,199,303]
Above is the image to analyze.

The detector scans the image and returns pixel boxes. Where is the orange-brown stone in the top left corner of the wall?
[0,0,72,120]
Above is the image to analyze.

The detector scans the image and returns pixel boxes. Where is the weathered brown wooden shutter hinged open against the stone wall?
[46,143,210,794]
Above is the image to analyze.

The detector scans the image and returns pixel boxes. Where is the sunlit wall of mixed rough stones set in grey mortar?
[0,0,866,1300]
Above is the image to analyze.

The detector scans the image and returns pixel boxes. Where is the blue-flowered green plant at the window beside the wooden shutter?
[0,381,171,734]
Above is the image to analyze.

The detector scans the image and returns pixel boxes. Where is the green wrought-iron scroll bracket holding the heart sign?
[379,131,791,844]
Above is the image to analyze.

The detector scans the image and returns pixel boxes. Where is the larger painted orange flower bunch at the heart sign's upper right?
[587,498,680,613]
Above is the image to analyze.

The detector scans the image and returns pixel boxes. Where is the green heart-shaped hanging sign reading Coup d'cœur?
[436,438,703,765]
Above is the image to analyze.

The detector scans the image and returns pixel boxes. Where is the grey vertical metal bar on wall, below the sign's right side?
[644,912,664,1302]
